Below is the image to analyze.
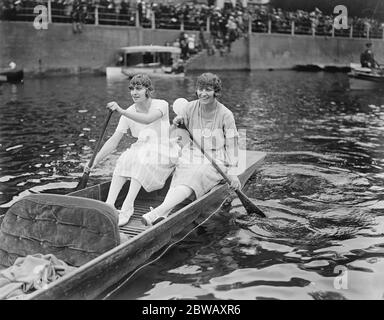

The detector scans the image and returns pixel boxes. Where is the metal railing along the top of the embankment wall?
[1,0,384,40]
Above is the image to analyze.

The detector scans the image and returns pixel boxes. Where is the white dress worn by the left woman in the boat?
[113,99,180,192]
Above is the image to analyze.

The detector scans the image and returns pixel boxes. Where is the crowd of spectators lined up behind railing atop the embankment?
[0,0,383,53]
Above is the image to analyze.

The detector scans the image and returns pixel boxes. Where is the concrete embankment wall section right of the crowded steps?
[188,33,384,70]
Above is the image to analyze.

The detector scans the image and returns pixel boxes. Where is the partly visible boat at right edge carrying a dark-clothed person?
[348,63,384,90]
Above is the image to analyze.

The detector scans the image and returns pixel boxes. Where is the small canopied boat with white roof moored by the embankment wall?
[106,46,184,80]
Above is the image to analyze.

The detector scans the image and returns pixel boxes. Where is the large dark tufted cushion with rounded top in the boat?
[0,194,120,267]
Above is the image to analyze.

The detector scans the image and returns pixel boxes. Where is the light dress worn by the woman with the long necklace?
[171,100,239,198]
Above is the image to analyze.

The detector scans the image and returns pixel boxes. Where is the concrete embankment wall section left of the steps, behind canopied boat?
[0,21,180,74]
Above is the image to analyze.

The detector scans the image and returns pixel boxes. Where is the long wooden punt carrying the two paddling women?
[28,151,265,300]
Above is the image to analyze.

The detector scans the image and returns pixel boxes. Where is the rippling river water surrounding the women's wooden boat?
[0,71,384,299]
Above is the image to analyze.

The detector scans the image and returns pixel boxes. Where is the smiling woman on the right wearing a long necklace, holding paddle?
[142,73,241,225]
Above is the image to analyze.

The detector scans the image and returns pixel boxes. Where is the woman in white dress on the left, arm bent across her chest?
[87,74,180,226]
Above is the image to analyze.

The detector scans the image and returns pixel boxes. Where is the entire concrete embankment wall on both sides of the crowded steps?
[0,21,384,75]
